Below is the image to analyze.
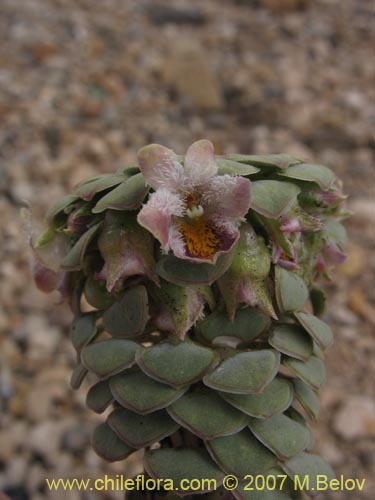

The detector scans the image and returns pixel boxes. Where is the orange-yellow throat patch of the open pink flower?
[179,217,220,258]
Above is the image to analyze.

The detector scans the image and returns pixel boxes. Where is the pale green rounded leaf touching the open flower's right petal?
[250,179,301,219]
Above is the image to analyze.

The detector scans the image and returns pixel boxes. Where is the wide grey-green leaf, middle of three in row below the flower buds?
[137,340,217,387]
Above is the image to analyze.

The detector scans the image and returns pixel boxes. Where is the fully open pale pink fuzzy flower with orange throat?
[138,140,250,264]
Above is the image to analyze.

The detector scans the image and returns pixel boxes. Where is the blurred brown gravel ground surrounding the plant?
[0,0,375,500]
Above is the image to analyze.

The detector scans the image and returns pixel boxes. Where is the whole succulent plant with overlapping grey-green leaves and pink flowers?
[32,140,346,500]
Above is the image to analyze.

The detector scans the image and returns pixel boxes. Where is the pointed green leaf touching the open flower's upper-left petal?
[92,173,149,214]
